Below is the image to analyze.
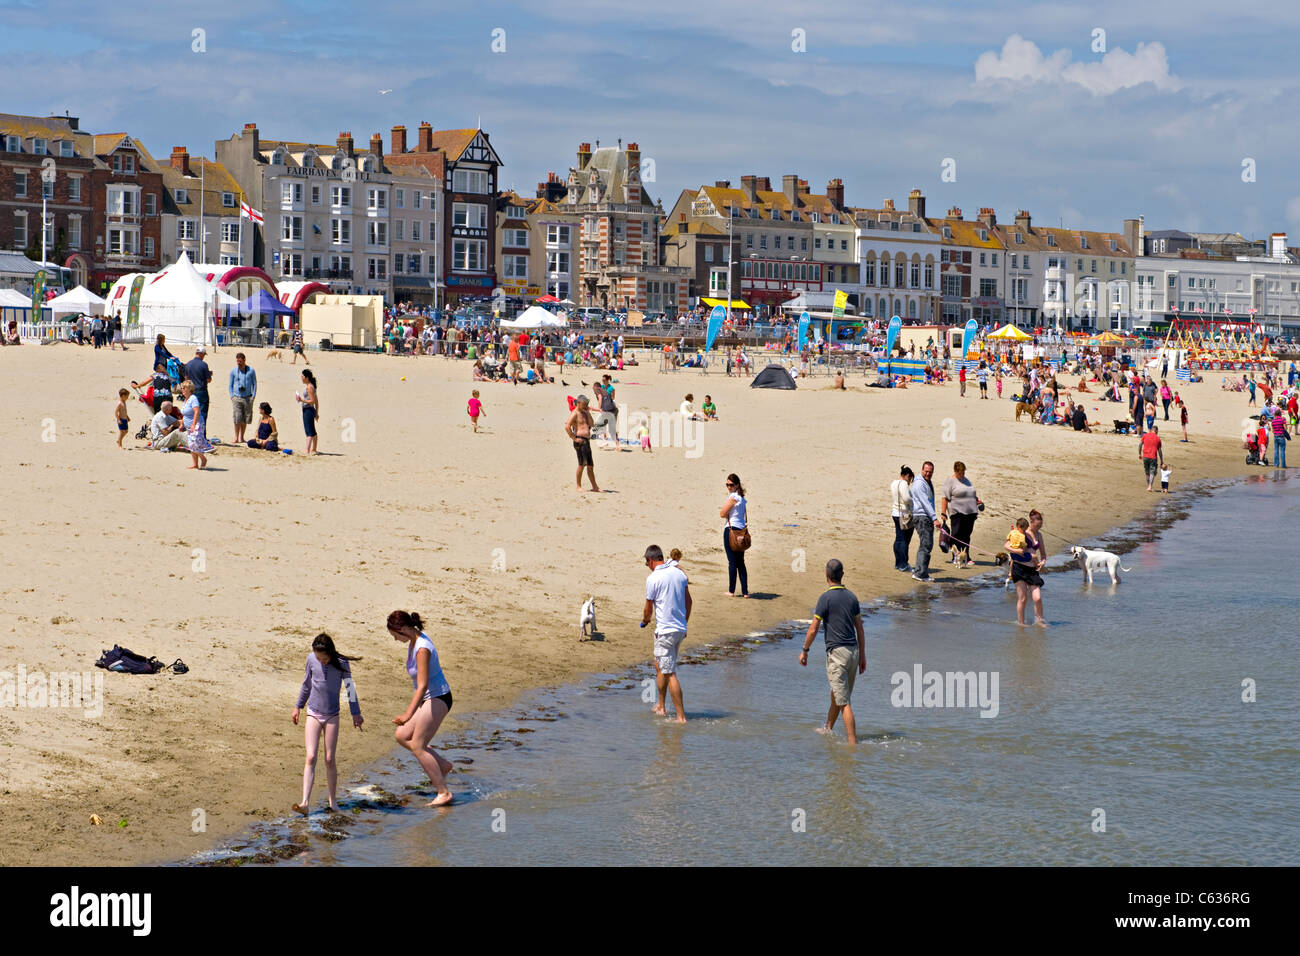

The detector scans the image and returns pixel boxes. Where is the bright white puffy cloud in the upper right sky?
[975,34,1183,96]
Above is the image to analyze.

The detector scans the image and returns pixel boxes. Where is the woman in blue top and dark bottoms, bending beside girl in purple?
[387,611,455,806]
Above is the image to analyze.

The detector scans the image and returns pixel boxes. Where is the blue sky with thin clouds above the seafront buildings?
[10,0,1300,245]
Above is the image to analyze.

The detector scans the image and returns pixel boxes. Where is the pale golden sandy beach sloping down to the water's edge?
[0,345,1252,865]
